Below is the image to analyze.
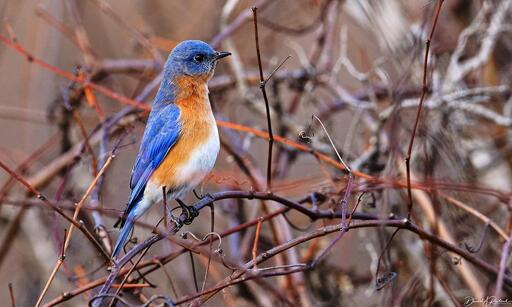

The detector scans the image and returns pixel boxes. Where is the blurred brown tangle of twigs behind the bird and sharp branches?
[0,0,512,306]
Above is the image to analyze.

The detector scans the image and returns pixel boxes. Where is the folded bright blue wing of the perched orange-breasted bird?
[125,103,181,214]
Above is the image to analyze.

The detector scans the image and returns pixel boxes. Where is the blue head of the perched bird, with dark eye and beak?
[166,40,231,80]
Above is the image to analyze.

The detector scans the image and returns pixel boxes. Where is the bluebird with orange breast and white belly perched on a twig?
[112,40,231,259]
